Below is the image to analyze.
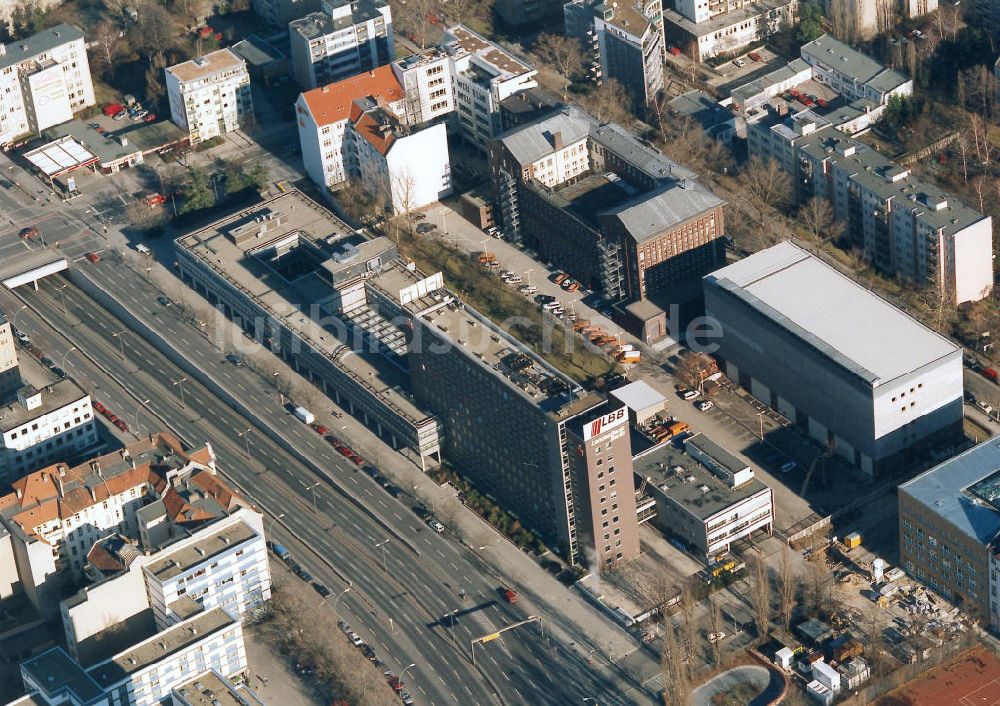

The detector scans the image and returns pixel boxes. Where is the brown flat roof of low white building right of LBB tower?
[632,443,768,520]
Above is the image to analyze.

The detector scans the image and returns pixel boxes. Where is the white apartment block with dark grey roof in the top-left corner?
[0,24,95,148]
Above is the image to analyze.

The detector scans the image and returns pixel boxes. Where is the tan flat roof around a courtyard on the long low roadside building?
[175,189,431,423]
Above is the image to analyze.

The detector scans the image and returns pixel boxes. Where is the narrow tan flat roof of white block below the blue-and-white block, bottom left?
[87,608,237,689]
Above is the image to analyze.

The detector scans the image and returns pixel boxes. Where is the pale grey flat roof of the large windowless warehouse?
[704,241,960,387]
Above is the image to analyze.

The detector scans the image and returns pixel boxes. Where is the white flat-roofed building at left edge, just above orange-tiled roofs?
[0,378,97,485]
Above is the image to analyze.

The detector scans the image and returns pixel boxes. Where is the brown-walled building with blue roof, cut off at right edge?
[899,438,1000,630]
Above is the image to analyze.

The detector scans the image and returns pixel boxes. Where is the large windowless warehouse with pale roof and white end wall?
[703,242,963,475]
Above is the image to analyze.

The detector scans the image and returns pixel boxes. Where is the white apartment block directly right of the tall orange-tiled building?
[392,47,455,125]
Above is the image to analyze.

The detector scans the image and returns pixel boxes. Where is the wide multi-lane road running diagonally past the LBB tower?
[0,260,649,704]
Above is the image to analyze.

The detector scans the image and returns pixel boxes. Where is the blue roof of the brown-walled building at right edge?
[899,439,1000,544]
